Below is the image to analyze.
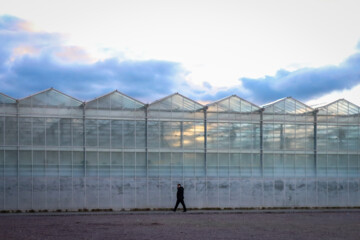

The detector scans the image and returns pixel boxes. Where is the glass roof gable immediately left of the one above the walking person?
[85,90,145,109]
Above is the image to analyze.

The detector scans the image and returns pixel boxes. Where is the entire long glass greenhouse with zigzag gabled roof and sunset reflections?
[0,89,360,210]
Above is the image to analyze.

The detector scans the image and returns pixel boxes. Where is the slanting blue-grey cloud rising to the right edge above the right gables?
[201,46,360,104]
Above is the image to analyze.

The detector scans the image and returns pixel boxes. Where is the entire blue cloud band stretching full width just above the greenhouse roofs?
[0,16,360,104]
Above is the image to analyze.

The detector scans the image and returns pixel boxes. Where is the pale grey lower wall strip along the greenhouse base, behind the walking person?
[0,177,360,211]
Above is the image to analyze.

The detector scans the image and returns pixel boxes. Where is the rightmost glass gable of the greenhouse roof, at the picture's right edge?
[317,99,360,115]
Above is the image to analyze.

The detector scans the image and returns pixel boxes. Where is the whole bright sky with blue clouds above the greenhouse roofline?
[0,0,360,106]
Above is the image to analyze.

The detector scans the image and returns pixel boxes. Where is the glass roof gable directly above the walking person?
[148,93,204,112]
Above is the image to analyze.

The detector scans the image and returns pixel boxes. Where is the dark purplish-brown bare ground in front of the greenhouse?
[0,211,360,240]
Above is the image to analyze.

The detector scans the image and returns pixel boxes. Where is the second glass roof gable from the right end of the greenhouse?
[262,97,314,114]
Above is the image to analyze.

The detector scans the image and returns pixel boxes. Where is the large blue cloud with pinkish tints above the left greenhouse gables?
[0,16,186,101]
